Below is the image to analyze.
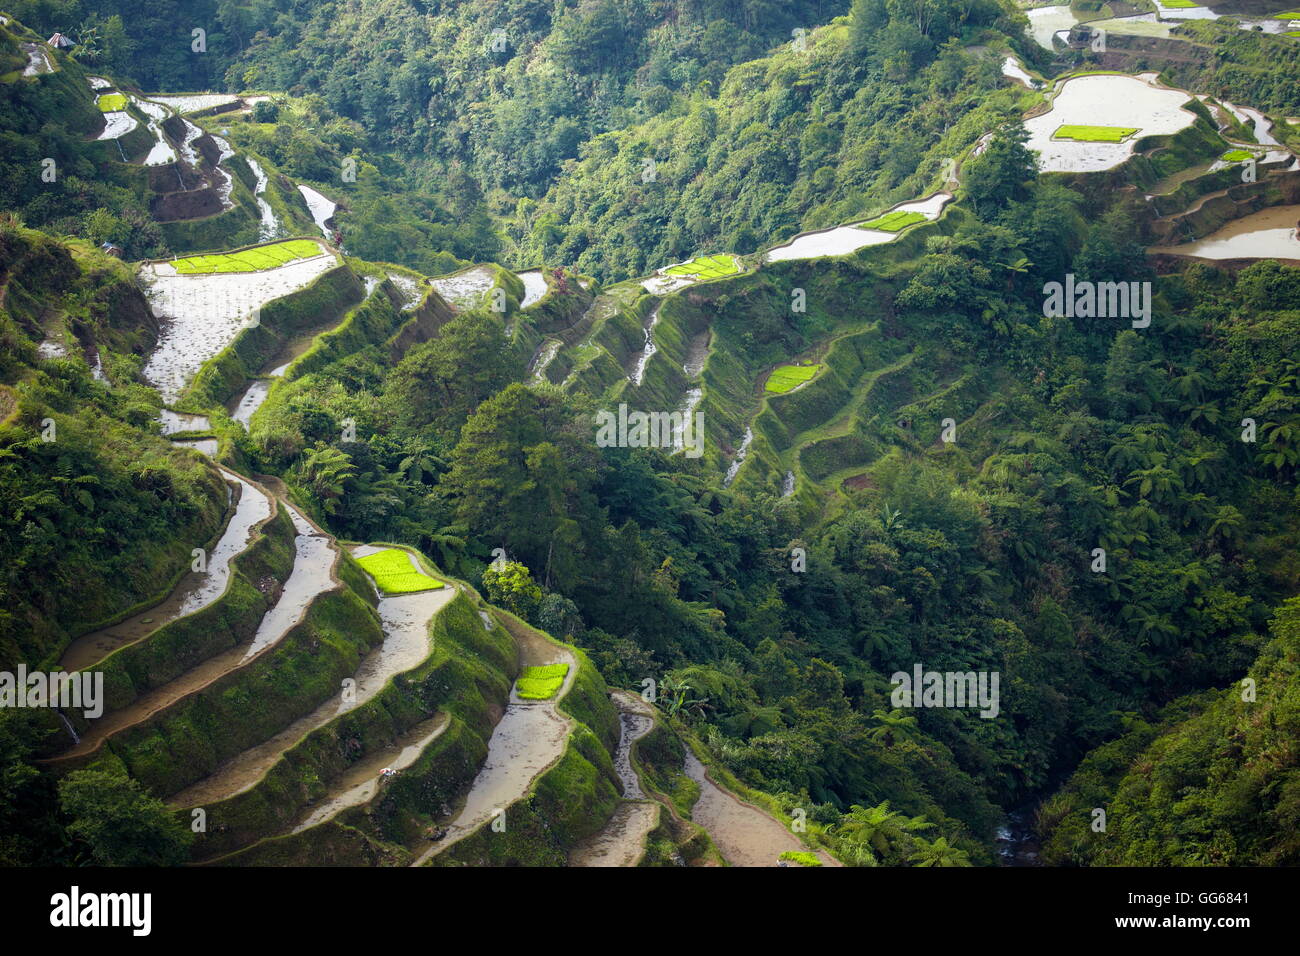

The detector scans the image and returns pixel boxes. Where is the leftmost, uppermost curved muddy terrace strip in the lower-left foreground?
[60,471,270,671]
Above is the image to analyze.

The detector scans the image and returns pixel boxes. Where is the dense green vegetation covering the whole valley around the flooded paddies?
[0,0,1300,866]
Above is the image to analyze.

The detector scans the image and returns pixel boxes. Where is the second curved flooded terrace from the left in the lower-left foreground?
[52,501,330,762]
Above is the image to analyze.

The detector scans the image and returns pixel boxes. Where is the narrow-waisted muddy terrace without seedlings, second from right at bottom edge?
[569,691,660,866]
